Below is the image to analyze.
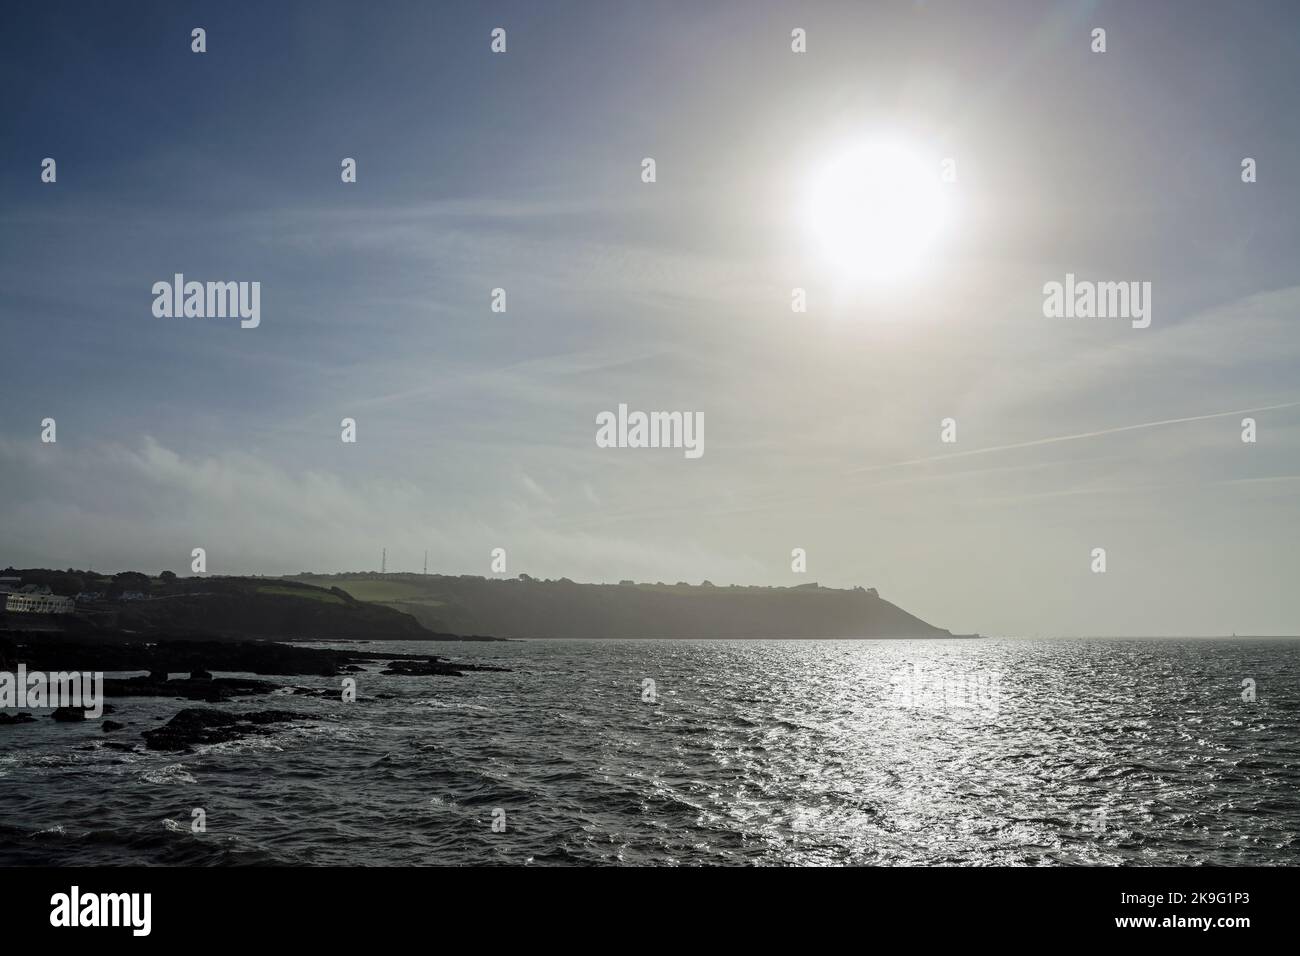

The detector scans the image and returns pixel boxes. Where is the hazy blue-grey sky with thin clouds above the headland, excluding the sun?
[0,0,1300,636]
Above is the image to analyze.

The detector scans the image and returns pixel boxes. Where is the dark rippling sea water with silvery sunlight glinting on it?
[0,639,1300,865]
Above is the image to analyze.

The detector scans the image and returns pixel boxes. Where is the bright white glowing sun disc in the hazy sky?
[803,142,949,284]
